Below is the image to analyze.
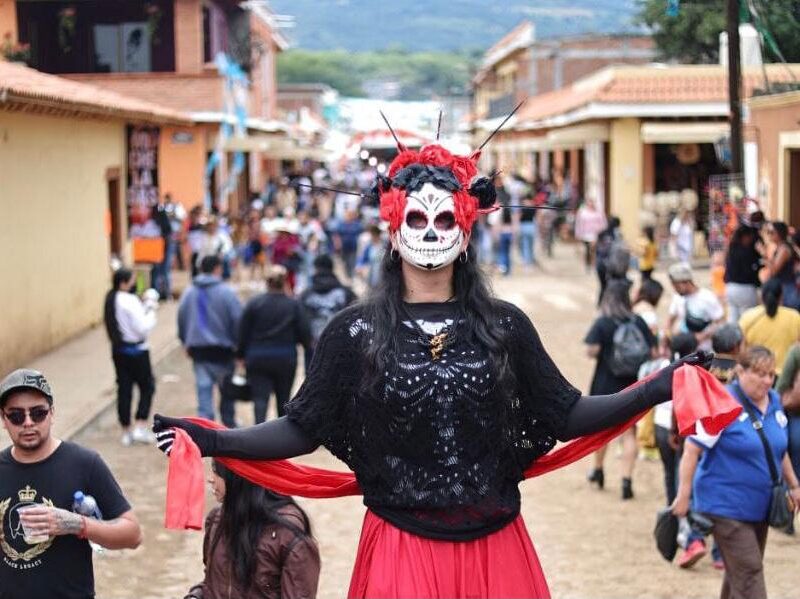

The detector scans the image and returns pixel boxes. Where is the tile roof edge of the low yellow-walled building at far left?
[0,60,191,124]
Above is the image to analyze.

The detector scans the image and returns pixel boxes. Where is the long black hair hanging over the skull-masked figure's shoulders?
[362,243,513,393]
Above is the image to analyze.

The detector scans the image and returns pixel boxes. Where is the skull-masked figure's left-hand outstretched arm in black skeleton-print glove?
[153,414,319,460]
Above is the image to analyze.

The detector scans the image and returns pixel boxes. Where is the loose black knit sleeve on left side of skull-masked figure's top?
[286,308,363,465]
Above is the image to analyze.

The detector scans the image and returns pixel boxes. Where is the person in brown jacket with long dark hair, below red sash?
[184,460,320,599]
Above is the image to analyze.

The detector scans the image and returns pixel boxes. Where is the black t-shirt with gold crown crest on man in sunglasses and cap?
[0,441,130,599]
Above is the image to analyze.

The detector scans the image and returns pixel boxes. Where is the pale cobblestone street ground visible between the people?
[70,245,800,599]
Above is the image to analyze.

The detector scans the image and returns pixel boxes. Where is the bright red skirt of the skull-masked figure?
[347,511,550,599]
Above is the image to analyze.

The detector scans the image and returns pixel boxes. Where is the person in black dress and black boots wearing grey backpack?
[583,280,657,499]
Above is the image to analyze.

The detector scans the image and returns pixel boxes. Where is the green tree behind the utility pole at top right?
[635,0,800,63]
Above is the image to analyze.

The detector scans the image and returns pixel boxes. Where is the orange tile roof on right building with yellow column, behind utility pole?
[517,64,800,127]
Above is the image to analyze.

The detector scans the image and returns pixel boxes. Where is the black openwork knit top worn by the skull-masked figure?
[287,301,580,540]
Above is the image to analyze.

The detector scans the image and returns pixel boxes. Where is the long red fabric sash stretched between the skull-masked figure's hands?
[166,366,742,528]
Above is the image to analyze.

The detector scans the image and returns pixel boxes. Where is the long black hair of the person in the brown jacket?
[211,460,312,589]
